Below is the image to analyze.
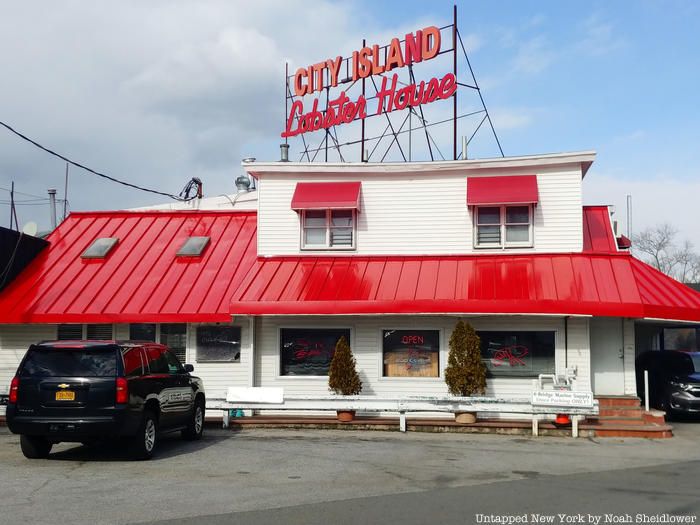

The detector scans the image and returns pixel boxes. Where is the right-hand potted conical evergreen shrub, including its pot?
[445,319,486,423]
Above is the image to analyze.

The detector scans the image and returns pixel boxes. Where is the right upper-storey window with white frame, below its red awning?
[474,205,533,248]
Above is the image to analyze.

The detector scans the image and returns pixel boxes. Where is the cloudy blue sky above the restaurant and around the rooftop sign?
[0,0,700,248]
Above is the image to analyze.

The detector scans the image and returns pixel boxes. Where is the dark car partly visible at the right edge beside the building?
[636,350,700,416]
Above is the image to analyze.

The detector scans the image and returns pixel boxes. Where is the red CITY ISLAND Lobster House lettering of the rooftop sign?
[282,26,457,137]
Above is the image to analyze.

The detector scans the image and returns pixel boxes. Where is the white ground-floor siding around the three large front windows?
[255,316,590,414]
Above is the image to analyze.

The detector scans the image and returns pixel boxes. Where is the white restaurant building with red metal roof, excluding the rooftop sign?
[0,152,700,434]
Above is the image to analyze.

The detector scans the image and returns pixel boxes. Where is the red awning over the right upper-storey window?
[467,175,539,206]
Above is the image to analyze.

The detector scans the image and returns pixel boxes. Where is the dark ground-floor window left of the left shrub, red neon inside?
[280,328,350,376]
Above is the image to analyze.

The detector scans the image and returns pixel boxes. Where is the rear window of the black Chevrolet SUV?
[19,347,117,377]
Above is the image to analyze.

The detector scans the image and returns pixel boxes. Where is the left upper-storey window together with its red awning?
[292,182,361,250]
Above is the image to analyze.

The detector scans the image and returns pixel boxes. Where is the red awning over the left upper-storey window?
[292,182,361,210]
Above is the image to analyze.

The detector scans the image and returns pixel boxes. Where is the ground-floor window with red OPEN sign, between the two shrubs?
[382,330,440,377]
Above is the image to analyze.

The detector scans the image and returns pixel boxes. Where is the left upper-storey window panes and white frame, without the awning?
[301,210,356,250]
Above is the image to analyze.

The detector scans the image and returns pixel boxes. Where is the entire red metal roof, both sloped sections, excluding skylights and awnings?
[5,207,700,323]
